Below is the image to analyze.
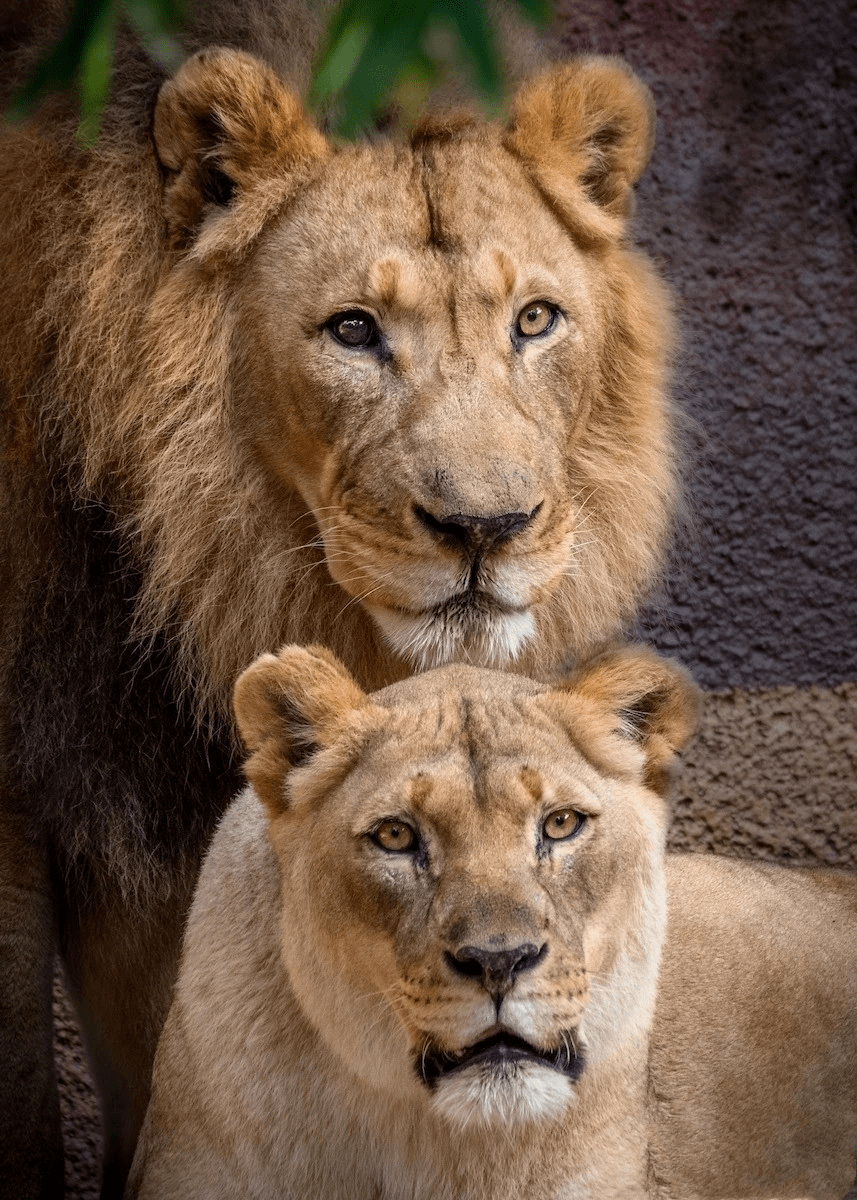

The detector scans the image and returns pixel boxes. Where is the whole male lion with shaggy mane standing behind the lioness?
[0,0,678,1196]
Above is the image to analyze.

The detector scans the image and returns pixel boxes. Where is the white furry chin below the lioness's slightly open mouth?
[432,1061,575,1129]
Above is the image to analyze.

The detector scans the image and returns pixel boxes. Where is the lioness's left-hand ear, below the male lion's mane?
[233,646,366,812]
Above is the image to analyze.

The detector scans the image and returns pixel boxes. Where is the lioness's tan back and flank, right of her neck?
[651,854,857,1198]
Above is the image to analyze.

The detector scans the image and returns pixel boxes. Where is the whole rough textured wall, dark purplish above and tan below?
[60,0,857,1200]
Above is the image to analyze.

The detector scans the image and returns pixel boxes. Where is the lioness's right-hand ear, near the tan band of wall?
[565,646,700,794]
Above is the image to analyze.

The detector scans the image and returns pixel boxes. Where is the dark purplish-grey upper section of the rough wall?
[561,0,857,688]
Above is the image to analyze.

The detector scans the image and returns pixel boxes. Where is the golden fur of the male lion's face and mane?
[0,39,675,720]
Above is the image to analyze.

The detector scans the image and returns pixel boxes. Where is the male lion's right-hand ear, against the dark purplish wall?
[504,55,654,242]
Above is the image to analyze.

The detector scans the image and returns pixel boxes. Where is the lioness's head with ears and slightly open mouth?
[235,647,695,1126]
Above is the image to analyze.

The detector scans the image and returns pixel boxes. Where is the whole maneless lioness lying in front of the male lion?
[127,647,857,1200]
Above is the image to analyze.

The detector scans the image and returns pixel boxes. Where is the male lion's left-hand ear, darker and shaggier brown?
[152,48,328,253]
